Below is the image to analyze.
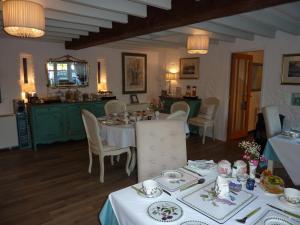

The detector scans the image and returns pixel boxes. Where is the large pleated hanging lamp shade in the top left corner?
[3,0,45,38]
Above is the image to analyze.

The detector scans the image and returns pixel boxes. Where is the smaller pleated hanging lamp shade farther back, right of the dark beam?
[187,35,209,54]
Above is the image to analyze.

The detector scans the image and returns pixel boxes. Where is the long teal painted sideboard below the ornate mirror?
[28,101,106,150]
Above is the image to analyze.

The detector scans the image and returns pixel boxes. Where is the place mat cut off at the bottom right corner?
[253,210,300,225]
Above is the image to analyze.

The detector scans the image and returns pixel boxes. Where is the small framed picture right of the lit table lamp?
[179,57,200,79]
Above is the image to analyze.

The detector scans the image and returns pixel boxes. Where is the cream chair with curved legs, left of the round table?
[81,109,131,183]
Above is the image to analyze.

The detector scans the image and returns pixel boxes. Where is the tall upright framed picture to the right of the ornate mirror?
[122,52,147,94]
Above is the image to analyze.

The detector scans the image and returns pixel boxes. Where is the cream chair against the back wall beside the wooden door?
[188,97,220,144]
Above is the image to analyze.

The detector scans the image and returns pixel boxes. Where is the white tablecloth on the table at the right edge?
[269,135,300,185]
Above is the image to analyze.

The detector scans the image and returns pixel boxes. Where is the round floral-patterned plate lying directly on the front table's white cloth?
[147,201,183,222]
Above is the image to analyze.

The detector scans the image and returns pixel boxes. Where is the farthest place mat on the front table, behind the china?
[186,160,217,176]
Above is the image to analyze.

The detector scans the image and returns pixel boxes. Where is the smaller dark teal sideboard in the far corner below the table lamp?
[159,96,201,134]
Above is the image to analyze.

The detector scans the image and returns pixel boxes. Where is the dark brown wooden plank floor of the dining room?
[0,136,296,225]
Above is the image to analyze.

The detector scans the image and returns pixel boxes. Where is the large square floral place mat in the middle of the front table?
[178,182,257,223]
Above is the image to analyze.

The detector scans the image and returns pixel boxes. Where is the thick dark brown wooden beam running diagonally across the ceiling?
[65,0,297,50]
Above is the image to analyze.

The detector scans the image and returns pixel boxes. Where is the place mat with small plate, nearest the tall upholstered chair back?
[153,170,199,192]
